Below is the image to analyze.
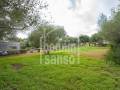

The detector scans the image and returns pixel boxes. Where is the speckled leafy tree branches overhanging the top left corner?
[0,0,47,40]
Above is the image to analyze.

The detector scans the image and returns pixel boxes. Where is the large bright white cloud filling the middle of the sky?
[44,0,100,36]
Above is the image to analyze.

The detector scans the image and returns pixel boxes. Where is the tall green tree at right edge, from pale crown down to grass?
[101,7,120,64]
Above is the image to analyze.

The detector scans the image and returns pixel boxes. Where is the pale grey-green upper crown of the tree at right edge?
[101,11,120,44]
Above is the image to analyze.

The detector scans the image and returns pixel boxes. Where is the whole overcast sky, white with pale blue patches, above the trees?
[19,0,118,37]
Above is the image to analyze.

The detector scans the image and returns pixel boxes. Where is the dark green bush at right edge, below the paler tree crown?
[107,45,120,65]
